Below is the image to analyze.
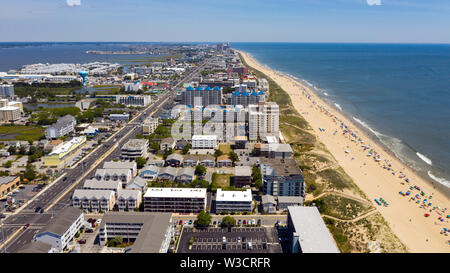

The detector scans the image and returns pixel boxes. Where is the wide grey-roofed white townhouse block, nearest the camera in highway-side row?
[72,189,116,211]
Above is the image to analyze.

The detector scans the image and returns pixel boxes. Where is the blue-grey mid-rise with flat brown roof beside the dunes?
[259,158,305,197]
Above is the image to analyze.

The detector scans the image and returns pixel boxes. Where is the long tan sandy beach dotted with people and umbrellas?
[238,51,450,253]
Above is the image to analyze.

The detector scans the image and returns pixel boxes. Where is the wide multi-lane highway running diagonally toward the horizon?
[0,55,212,253]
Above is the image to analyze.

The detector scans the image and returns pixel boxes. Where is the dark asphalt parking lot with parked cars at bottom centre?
[178,227,282,253]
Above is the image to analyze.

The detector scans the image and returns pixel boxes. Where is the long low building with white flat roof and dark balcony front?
[144,188,207,213]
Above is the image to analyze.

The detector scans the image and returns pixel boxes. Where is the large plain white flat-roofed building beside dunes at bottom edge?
[287,206,339,253]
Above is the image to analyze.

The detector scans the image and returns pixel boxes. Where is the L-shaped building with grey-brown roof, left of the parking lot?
[99,211,174,253]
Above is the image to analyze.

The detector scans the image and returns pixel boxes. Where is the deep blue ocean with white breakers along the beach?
[231,43,450,188]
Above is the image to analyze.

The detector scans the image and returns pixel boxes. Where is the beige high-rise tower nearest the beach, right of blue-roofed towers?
[248,102,280,140]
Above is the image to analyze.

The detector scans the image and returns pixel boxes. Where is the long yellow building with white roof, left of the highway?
[43,136,86,166]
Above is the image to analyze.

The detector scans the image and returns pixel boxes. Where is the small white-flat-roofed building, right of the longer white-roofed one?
[216,189,252,213]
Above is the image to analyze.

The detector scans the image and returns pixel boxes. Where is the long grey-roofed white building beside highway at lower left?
[33,207,84,252]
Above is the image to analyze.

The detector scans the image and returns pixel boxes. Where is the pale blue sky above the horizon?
[0,0,450,43]
